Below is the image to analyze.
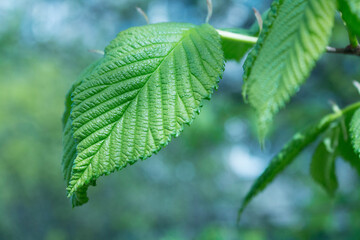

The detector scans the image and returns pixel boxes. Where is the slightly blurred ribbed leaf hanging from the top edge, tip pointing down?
[243,0,336,139]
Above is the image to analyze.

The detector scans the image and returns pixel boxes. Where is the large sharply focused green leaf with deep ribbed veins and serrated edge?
[63,23,224,205]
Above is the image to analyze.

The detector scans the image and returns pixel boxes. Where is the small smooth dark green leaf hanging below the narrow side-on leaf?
[310,126,340,196]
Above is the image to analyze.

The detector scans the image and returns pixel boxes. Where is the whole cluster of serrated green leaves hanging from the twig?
[62,0,360,223]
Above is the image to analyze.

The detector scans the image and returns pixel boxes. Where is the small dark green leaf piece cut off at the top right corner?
[339,0,360,36]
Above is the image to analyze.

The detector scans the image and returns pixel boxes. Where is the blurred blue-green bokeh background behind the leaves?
[0,0,360,240]
